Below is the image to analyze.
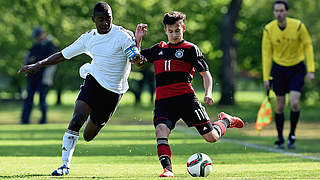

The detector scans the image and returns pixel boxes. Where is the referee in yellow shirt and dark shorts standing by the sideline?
[262,0,315,149]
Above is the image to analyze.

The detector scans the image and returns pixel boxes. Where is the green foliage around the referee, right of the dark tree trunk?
[236,0,320,91]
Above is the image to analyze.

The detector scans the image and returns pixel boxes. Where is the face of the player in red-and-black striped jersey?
[164,20,186,44]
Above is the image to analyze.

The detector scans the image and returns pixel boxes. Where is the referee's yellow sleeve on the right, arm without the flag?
[299,24,315,72]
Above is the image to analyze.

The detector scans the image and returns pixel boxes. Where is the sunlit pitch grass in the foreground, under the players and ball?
[0,124,320,179]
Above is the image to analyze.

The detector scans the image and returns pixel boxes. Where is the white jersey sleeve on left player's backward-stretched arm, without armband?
[61,33,88,59]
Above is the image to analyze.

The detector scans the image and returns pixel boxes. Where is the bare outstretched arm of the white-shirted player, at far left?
[18,52,67,73]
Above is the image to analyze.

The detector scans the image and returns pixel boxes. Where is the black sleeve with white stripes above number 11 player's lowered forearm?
[191,45,209,72]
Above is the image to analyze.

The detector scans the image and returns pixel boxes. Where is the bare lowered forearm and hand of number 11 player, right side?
[199,71,214,105]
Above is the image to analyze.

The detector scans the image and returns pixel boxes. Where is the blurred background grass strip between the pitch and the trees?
[0,91,320,124]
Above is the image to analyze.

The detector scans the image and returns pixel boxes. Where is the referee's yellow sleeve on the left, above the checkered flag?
[262,28,272,81]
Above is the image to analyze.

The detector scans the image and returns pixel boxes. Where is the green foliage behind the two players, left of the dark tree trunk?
[0,0,228,94]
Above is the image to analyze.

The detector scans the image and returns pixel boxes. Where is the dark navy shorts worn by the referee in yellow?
[271,62,306,96]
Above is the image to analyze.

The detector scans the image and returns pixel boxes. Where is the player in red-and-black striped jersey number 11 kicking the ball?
[136,11,244,177]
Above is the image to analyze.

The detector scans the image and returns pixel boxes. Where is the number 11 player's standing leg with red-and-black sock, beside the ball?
[156,123,174,177]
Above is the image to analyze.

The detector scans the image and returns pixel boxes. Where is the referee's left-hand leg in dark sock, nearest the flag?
[274,96,286,149]
